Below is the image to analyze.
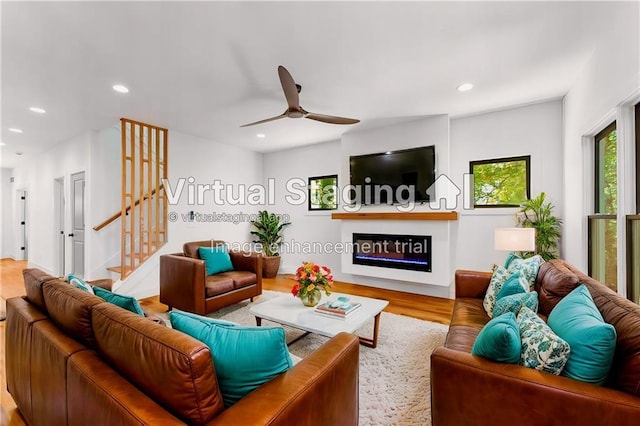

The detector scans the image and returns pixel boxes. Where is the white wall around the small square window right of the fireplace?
[450,100,564,270]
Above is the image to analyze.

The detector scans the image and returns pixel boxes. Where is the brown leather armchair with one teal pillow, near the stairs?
[160,240,262,315]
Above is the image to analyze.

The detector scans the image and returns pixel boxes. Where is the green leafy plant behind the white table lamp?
[518,192,562,260]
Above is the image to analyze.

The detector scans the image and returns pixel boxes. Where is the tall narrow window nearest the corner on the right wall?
[588,121,618,291]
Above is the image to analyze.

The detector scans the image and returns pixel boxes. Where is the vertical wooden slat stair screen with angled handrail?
[93,118,168,279]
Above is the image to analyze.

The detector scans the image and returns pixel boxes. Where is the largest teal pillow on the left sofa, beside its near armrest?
[169,312,293,407]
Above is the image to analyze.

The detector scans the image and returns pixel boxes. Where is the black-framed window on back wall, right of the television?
[469,155,531,208]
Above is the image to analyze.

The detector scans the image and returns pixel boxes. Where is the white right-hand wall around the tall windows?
[563,2,640,272]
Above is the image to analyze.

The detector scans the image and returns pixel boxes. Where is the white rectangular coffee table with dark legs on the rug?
[249,293,389,348]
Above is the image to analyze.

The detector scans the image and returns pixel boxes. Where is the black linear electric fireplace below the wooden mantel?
[353,234,431,272]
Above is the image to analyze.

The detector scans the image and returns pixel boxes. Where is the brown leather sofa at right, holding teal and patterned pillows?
[431,260,640,426]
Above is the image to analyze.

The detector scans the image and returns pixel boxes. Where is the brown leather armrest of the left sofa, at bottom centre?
[209,333,360,426]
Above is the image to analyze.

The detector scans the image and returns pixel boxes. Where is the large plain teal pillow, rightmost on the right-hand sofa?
[547,284,616,385]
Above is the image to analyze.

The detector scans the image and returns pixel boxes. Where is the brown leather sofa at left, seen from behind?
[6,269,359,426]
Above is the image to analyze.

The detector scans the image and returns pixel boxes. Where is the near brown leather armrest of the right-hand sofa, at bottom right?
[431,347,640,426]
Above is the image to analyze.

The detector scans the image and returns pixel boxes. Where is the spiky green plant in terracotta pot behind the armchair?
[251,210,291,278]
